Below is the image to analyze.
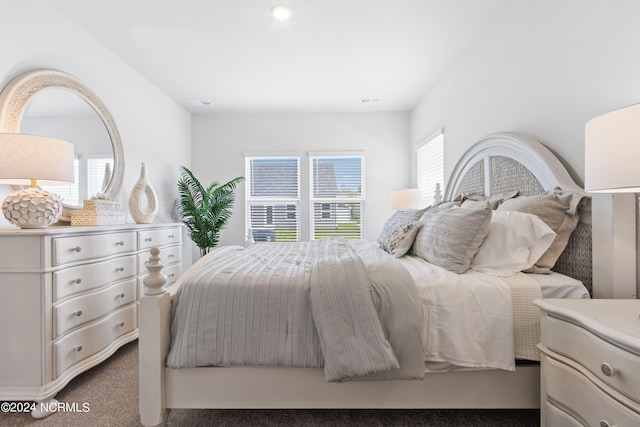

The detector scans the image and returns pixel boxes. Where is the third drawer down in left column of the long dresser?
[53,278,136,337]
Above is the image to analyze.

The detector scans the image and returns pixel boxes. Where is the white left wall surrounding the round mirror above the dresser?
[0,0,191,225]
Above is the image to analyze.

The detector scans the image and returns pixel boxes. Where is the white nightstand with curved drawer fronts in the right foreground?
[535,299,640,427]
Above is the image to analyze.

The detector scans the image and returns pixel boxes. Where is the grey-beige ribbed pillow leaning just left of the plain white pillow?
[412,208,491,273]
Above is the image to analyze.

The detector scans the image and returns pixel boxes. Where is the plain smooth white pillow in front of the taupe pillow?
[470,210,556,276]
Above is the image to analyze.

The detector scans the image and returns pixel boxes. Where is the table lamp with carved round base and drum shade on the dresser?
[0,133,74,228]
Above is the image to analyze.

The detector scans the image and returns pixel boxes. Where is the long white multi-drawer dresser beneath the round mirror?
[0,224,183,410]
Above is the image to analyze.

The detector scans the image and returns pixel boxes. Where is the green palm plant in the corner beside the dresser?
[178,166,244,256]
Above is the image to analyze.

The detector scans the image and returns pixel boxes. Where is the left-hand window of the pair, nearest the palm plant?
[245,156,300,242]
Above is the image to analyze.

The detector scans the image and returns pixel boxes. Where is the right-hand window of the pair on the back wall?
[309,153,364,240]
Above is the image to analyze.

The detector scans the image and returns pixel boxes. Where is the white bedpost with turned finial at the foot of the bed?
[138,247,171,426]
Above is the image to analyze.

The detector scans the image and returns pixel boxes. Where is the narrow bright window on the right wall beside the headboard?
[416,129,444,205]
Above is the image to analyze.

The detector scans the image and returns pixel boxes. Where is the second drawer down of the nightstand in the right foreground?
[541,354,640,426]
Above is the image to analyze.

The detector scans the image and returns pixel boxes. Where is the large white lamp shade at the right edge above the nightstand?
[584,104,640,193]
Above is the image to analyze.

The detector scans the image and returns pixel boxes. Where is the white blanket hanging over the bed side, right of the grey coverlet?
[400,256,539,371]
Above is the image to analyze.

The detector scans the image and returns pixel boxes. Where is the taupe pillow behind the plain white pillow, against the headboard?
[498,189,586,273]
